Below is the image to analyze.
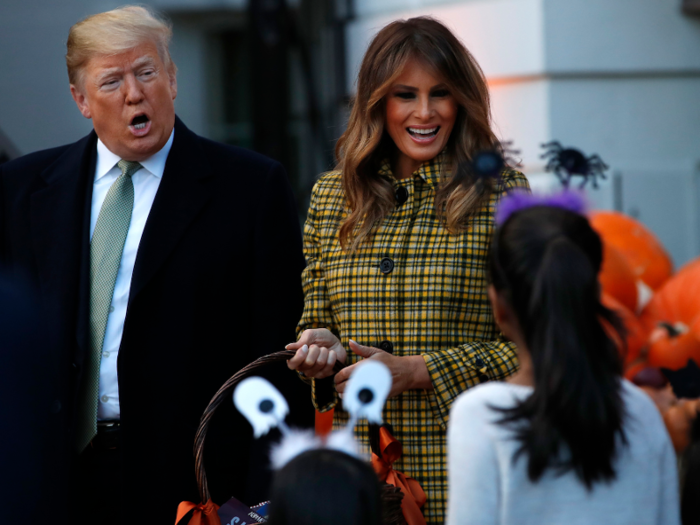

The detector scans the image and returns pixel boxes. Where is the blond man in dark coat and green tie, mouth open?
[0,6,312,525]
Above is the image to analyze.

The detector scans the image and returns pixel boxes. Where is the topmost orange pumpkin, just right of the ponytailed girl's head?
[590,211,673,290]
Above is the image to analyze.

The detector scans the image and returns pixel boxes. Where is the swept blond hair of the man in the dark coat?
[66,5,176,85]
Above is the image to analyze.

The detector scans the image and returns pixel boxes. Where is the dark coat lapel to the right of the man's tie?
[129,119,210,304]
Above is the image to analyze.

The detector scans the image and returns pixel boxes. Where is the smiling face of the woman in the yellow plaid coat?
[386,59,457,178]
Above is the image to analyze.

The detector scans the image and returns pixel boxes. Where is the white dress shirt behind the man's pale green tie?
[90,130,175,420]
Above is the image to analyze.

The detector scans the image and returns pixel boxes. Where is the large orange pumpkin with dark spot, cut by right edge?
[641,261,700,370]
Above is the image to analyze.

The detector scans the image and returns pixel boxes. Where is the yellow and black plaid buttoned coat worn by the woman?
[298,157,528,523]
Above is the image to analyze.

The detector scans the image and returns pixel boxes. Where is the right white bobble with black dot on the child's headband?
[343,359,391,427]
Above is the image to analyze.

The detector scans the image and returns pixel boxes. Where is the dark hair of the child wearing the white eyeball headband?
[268,449,382,525]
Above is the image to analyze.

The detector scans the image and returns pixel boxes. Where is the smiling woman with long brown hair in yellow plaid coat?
[287,17,527,523]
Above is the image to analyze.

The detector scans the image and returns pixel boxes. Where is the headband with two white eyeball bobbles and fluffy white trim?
[233,360,391,469]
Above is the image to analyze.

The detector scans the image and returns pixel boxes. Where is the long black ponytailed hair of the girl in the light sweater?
[490,206,625,489]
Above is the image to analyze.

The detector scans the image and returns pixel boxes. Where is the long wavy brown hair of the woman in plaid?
[335,16,500,252]
